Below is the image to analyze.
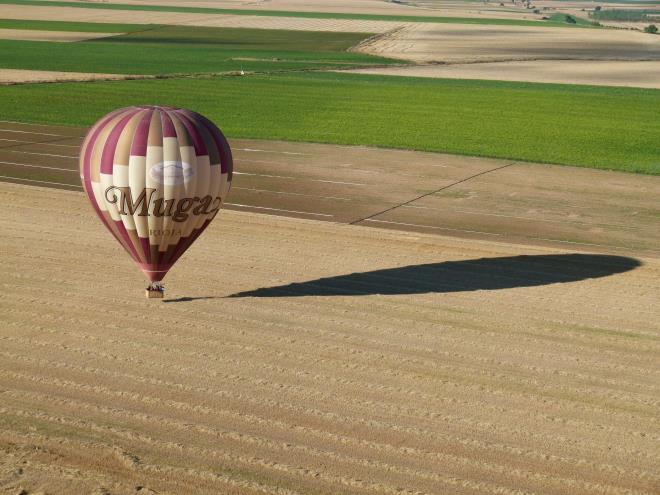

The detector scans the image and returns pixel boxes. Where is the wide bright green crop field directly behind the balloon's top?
[0,73,660,174]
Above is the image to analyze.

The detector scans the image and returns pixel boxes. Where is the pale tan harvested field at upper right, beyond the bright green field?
[358,14,660,87]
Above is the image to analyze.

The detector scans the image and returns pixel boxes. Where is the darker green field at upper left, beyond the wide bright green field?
[0,23,397,75]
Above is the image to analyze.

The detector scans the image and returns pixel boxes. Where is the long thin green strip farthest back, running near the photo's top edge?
[0,0,600,27]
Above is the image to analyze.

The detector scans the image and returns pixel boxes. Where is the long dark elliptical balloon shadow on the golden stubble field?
[228,254,641,297]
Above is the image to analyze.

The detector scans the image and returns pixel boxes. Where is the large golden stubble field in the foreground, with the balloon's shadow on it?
[0,184,660,495]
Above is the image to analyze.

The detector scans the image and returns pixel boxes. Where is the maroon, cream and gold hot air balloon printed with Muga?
[80,106,233,298]
